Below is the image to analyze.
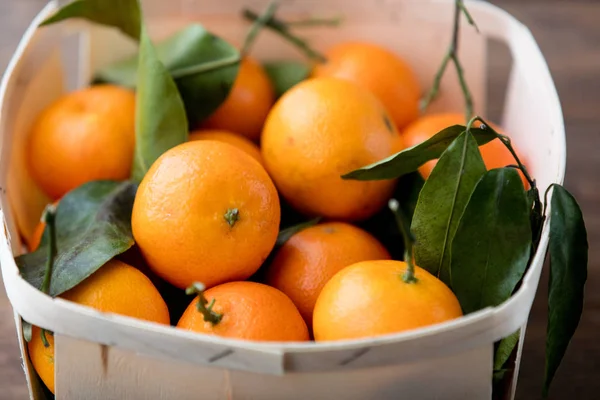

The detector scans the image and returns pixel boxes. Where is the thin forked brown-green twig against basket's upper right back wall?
[421,0,477,121]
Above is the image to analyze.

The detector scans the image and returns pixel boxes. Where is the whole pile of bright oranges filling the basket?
[27,42,512,390]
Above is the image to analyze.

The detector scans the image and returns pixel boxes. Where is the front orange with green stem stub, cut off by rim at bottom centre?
[177,282,308,342]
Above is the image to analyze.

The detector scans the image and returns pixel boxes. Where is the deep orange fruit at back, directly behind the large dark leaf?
[202,57,275,140]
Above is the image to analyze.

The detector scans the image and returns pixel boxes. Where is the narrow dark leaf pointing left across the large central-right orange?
[342,125,496,181]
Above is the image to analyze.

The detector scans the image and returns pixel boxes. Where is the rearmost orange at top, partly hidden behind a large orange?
[312,42,421,129]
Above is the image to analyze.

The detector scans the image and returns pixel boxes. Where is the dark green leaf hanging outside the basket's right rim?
[543,185,588,397]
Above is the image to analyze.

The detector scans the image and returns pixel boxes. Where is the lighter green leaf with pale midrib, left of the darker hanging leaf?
[411,132,485,286]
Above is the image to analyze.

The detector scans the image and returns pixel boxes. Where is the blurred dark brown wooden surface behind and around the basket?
[0,0,600,400]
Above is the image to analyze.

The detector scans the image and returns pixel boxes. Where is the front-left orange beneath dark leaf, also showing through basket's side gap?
[28,260,169,393]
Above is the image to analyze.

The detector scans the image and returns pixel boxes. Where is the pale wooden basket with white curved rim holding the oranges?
[0,0,565,400]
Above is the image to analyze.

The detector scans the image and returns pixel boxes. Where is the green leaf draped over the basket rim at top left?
[40,0,141,40]
